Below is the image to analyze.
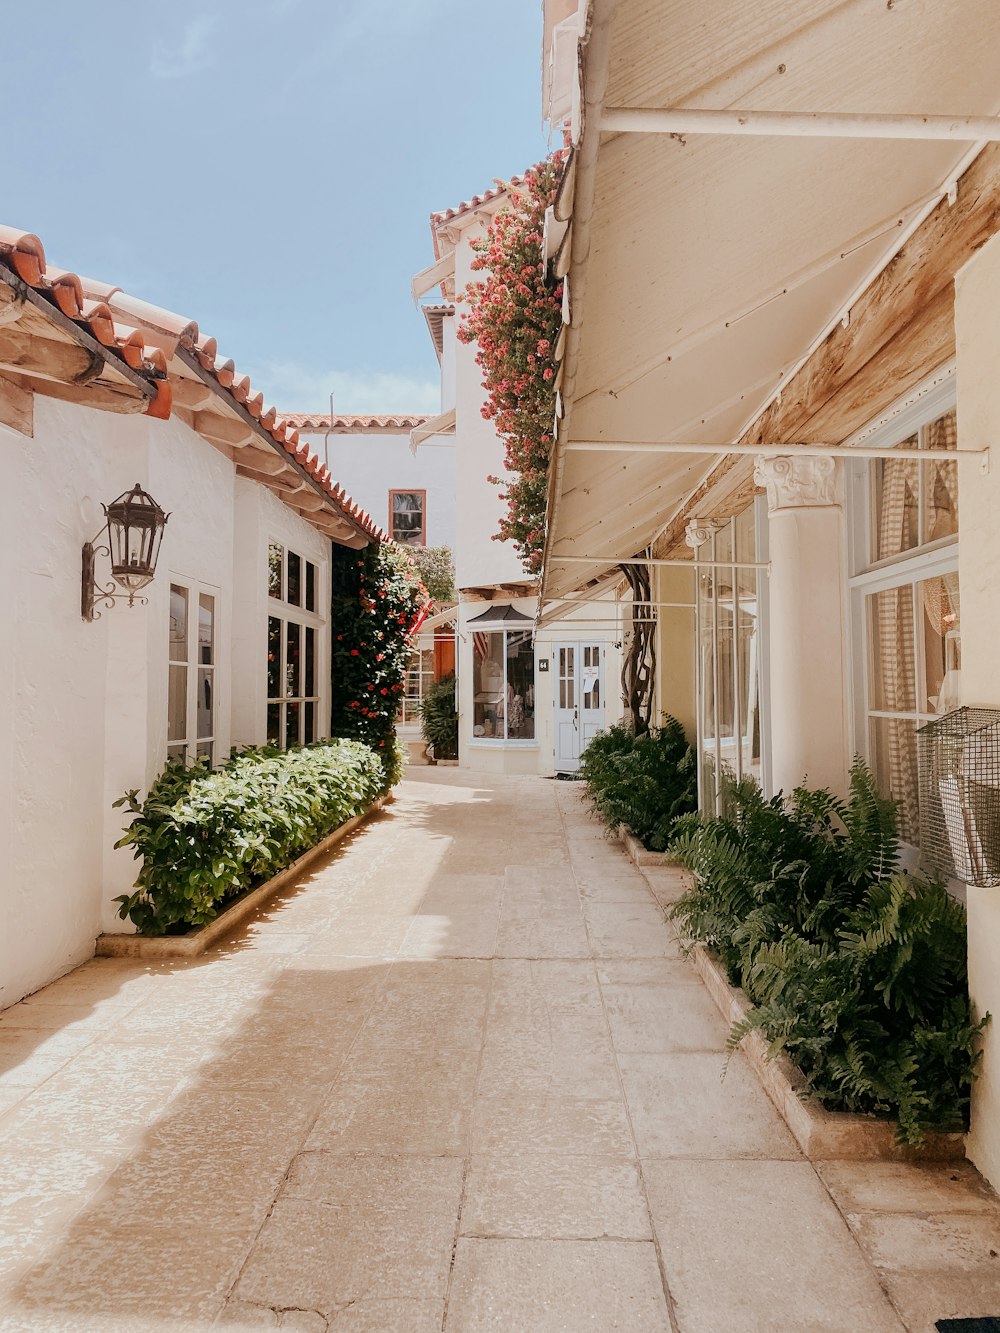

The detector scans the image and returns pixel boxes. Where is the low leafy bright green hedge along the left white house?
[115,740,386,934]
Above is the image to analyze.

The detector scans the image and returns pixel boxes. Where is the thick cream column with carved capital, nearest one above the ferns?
[755,456,849,794]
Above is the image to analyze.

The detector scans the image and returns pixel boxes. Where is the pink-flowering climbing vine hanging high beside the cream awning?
[459,151,565,573]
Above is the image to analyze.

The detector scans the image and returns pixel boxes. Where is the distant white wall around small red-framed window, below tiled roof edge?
[301,431,455,551]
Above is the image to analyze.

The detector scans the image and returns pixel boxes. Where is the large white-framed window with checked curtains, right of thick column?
[849,380,961,845]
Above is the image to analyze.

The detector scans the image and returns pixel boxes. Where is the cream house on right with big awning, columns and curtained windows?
[541,0,1000,1185]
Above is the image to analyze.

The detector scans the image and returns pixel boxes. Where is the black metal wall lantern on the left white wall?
[80,481,169,620]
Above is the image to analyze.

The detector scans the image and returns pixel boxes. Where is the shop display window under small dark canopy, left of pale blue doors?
[472,629,535,741]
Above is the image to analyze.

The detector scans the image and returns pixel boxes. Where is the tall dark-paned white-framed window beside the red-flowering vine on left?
[267,541,324,749]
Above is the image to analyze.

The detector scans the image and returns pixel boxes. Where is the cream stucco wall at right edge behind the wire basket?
[955,226,1000,1186]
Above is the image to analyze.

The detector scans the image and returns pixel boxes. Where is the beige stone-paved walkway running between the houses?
[0,769,1000,1333]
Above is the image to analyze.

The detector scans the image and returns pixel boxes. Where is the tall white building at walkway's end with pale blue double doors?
[411,187,624,774]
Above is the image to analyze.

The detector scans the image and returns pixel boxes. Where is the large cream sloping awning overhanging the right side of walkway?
[543,0,1000,600]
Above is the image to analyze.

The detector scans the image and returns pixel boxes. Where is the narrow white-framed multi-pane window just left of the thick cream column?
[696,504,767,814]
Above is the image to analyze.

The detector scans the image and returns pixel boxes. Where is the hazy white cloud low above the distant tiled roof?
[249,361,441,412]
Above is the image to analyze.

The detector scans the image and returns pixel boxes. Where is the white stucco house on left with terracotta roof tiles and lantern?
[0,229,381,1008]
